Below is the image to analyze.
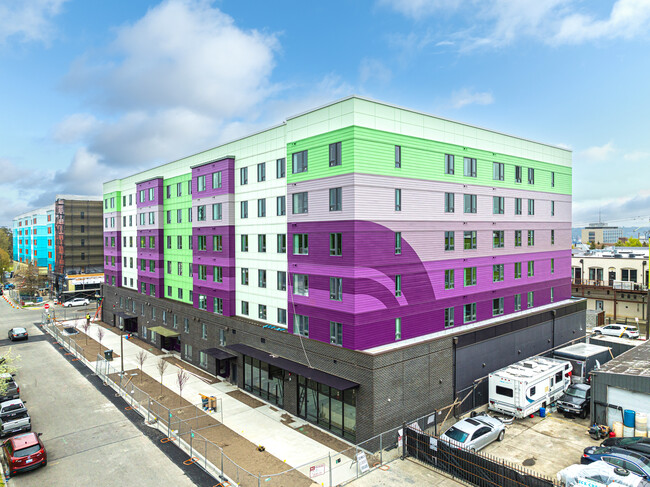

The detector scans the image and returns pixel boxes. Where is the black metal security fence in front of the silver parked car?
[404,425,561,487]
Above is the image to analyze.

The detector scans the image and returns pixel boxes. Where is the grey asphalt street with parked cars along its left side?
[0,299,217,487]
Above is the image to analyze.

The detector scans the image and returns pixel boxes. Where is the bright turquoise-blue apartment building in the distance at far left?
[13,205,55,275]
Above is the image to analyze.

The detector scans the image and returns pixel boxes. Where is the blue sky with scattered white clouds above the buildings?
[0,0,650,226]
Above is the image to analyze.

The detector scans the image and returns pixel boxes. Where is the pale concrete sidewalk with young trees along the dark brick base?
[66,319,350,480]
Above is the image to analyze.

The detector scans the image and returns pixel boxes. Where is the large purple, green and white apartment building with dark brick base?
[103,97,585,440]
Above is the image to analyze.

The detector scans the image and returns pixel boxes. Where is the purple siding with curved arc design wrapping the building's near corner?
[288,221,571,349]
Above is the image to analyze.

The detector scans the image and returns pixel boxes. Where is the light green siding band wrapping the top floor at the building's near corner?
[287,126,571,194]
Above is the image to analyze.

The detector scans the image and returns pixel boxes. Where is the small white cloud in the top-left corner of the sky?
[0,0,68,44]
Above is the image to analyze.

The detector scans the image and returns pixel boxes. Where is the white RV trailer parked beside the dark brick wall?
[488,357,572,418]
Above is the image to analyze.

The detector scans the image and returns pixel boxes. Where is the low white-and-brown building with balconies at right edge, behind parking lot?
[571,247,649,323]
